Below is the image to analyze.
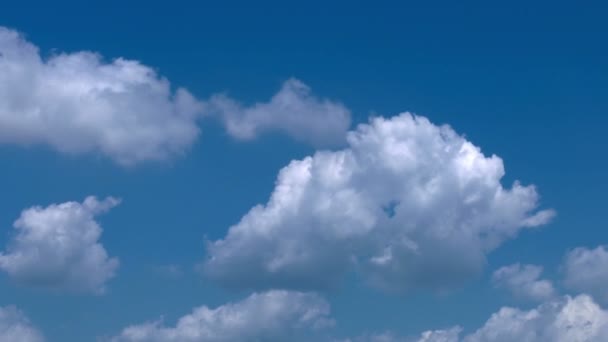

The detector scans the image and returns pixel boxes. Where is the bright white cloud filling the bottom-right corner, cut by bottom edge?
[463,295,608,342]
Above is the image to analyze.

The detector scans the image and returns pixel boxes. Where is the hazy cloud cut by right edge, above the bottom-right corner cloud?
[564,246,608,303]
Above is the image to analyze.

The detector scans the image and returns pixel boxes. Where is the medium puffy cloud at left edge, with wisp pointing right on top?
[0,197,119,294]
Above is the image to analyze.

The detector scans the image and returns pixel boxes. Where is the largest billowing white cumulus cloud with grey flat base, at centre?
[203,113,553,291]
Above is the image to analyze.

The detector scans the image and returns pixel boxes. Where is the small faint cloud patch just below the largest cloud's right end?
[492,264,555,301]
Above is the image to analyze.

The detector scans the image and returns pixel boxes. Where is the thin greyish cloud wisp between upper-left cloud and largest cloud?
[207,79,351,146]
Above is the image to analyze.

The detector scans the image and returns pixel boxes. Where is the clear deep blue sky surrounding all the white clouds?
[0,0,608,341]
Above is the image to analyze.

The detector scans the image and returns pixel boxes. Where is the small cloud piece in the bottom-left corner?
[0,306,44,342]
